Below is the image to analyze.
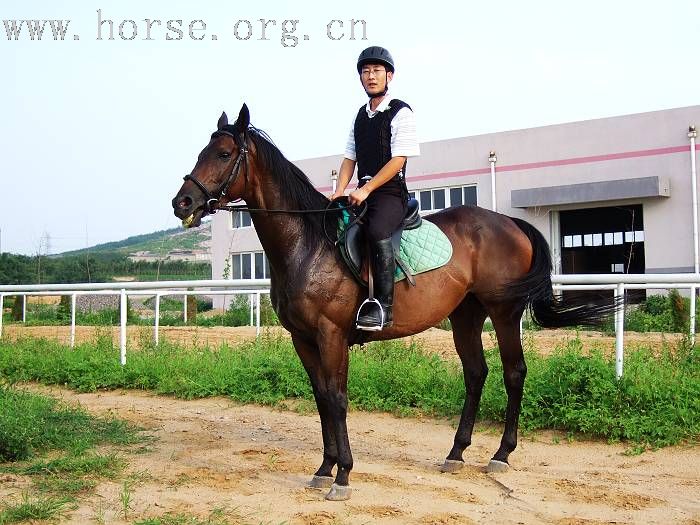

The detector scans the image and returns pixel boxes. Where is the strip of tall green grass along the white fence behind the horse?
[0,336,700,447]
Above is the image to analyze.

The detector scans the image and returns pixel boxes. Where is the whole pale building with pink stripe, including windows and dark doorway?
[212,106,700,306]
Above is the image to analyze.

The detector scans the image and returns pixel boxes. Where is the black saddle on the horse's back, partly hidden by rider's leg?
[337,199,423,286]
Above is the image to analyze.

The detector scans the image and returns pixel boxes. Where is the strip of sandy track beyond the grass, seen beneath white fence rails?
[3,324,681,359]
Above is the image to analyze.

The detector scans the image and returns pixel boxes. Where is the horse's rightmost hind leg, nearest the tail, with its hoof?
[487,298,527,472]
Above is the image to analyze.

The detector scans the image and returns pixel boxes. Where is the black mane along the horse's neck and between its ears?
[223,125,330,242]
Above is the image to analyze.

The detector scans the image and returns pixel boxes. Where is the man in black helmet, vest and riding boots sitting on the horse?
[331,46,420,331]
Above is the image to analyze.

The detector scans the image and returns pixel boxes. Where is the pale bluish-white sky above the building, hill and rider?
[0,0,700,255]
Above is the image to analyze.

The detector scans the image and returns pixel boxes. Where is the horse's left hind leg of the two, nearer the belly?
[441,294,488,472]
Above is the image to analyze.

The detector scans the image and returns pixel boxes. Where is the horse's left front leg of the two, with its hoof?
[292,335,338,489]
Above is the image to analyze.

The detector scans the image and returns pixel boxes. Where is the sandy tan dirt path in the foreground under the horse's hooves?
[0,385,700,525]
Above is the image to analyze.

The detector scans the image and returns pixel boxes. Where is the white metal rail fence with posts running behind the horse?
[0,273,700,377]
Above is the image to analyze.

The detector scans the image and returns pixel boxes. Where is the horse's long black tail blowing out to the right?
[499,217,617,328]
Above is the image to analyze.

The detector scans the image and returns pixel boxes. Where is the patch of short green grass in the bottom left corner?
[0,384,147,525]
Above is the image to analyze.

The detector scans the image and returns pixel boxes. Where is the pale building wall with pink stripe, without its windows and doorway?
[212,106,700,308]
